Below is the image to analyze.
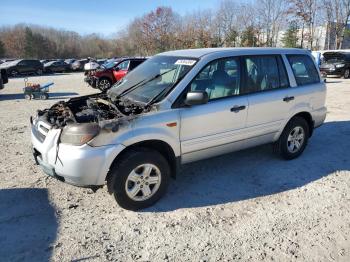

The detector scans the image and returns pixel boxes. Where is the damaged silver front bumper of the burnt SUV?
[31,123,125,187]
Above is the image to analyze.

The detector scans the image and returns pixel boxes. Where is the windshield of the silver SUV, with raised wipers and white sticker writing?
[108,56,197,103]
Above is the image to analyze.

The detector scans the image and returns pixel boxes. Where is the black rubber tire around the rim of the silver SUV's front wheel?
[107,148,170,210]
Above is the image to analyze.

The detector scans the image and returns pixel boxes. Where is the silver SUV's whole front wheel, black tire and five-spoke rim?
[107,148,170,210]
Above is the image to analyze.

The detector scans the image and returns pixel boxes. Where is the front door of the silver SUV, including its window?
[180,57,248,163]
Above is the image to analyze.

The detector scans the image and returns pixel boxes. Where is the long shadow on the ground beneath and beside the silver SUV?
[148,121,350,212]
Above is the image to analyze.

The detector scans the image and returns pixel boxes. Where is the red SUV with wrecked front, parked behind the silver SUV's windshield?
[85,57,146,91]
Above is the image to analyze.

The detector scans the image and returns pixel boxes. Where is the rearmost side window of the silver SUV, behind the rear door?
[287,55,320,86]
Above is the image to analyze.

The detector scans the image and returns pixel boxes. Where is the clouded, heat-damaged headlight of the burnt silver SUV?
[61,123,101,146]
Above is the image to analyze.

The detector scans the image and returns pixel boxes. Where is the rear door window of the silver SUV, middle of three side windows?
[242,55,289,94]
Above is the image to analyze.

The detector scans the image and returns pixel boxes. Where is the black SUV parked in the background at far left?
[0,59,44,77]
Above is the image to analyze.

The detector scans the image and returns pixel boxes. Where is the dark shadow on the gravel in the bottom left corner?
[0,188,58,261]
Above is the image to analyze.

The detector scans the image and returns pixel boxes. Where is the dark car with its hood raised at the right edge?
[320,52,350,78]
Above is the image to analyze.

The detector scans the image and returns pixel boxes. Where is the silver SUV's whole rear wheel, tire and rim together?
[274,117,310,160]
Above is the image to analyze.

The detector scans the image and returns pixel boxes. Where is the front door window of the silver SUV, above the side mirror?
[190,57,240,100]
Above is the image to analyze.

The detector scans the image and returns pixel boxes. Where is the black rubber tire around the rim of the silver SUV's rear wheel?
[274,116,310,160]
